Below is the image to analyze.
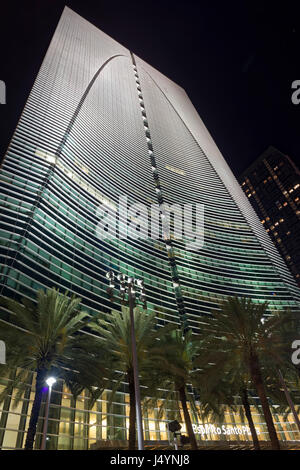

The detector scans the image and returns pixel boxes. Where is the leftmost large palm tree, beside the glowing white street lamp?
[0,289,107,449]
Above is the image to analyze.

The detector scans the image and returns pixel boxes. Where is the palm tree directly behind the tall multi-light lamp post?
[92,306,174,450]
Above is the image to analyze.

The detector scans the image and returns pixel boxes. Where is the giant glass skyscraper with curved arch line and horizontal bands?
[0,8,299,448]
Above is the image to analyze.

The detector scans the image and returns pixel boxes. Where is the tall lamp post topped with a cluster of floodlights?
[106,271,146,450]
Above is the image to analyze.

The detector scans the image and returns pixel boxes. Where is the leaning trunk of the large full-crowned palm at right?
[249,353,280,450]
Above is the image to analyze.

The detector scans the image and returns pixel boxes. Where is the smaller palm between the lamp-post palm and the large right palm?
[145,330,199,450]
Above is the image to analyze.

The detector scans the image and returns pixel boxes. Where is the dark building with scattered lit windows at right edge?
[240,147,300,285]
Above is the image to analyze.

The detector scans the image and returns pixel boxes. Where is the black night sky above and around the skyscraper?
[0,0,300,176]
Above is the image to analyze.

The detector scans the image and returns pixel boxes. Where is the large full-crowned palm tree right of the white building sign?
[198,297,290,450]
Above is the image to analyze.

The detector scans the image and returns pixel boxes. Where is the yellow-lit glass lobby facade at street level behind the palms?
[0,381,300,450]
